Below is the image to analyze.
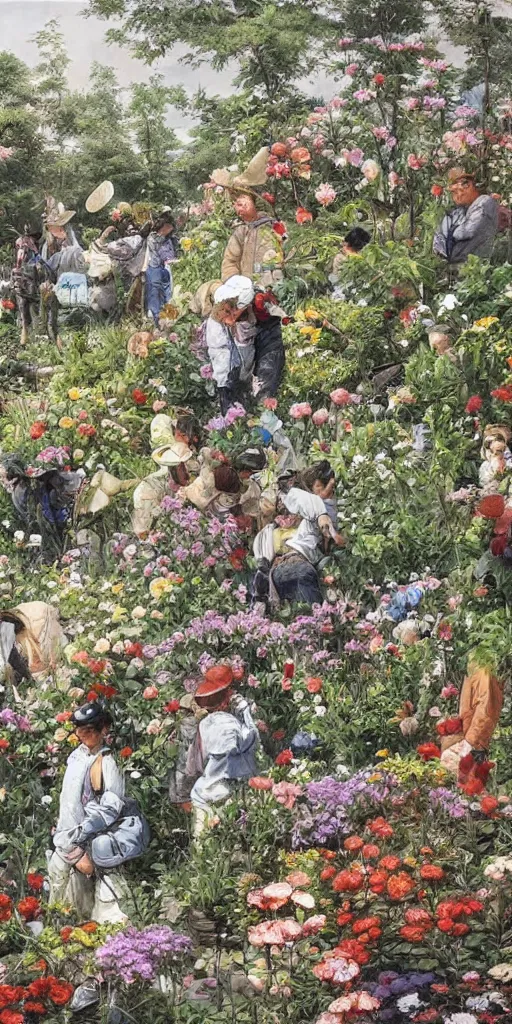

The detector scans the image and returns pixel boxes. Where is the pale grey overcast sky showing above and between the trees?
[0,0,471,136]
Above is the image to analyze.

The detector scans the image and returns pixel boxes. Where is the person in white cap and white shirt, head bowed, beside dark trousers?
[205,274,256,416]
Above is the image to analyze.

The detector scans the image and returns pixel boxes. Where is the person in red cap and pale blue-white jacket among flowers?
[189,665,259,837]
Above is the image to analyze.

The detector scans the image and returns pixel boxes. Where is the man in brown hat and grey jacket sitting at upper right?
[433,167,499,265]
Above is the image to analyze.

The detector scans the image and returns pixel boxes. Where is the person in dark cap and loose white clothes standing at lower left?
[48,702,127,924]
